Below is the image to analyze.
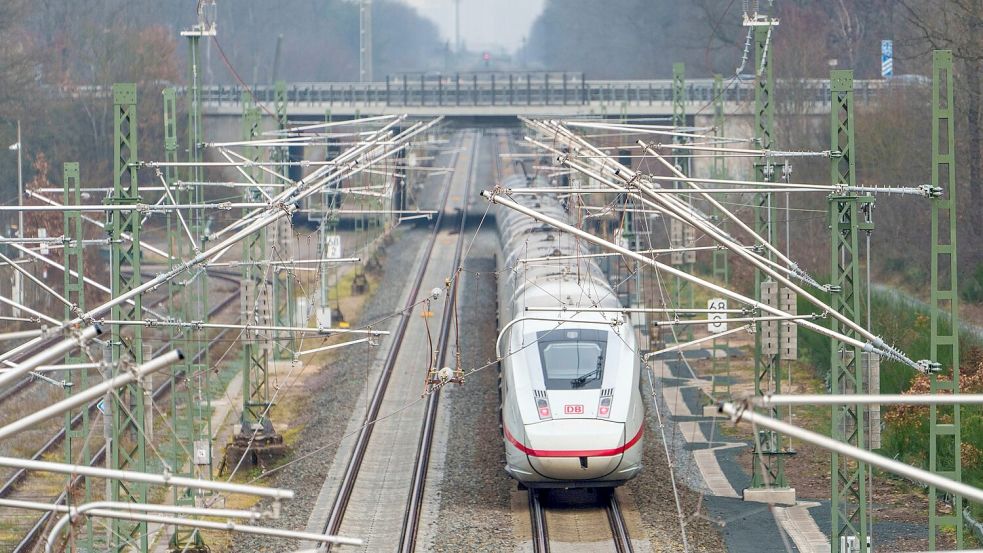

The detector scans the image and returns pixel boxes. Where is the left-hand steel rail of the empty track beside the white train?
[322,132,456,549]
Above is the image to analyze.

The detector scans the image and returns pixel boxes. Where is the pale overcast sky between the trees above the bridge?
[403,0,545,51]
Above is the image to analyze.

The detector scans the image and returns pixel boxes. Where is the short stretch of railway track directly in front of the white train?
[529,489,634,553]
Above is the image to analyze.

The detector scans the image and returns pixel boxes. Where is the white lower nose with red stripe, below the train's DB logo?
[526,419,625,480]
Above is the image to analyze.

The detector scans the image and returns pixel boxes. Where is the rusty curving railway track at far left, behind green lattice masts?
[0,272,239,553]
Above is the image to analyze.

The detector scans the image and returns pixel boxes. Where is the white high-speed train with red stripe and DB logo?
[496,177,644,488]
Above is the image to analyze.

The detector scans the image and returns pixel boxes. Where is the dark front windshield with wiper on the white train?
[536,328,608,390]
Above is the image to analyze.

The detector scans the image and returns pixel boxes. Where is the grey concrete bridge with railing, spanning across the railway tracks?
[203,72,900,124]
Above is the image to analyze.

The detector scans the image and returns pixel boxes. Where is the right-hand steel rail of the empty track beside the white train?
[399,130,481,553]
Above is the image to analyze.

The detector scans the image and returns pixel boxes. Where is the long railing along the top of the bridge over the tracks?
[202,73,921,109]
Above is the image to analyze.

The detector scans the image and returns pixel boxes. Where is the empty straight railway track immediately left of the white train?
[322,135,478,551]
